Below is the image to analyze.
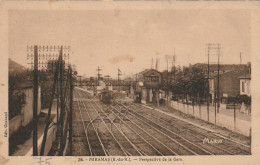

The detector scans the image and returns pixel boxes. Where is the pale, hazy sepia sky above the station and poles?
[8,9,251,77]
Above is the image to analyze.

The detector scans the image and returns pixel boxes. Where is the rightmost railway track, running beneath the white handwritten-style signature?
[117,104,249,155]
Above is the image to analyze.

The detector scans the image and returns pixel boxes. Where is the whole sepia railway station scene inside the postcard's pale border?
[8,10,252,156]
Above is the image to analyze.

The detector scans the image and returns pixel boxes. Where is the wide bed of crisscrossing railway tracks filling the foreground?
[72,89,250,156]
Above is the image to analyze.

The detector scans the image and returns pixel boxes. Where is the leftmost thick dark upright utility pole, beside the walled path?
[33,45,39,156]
